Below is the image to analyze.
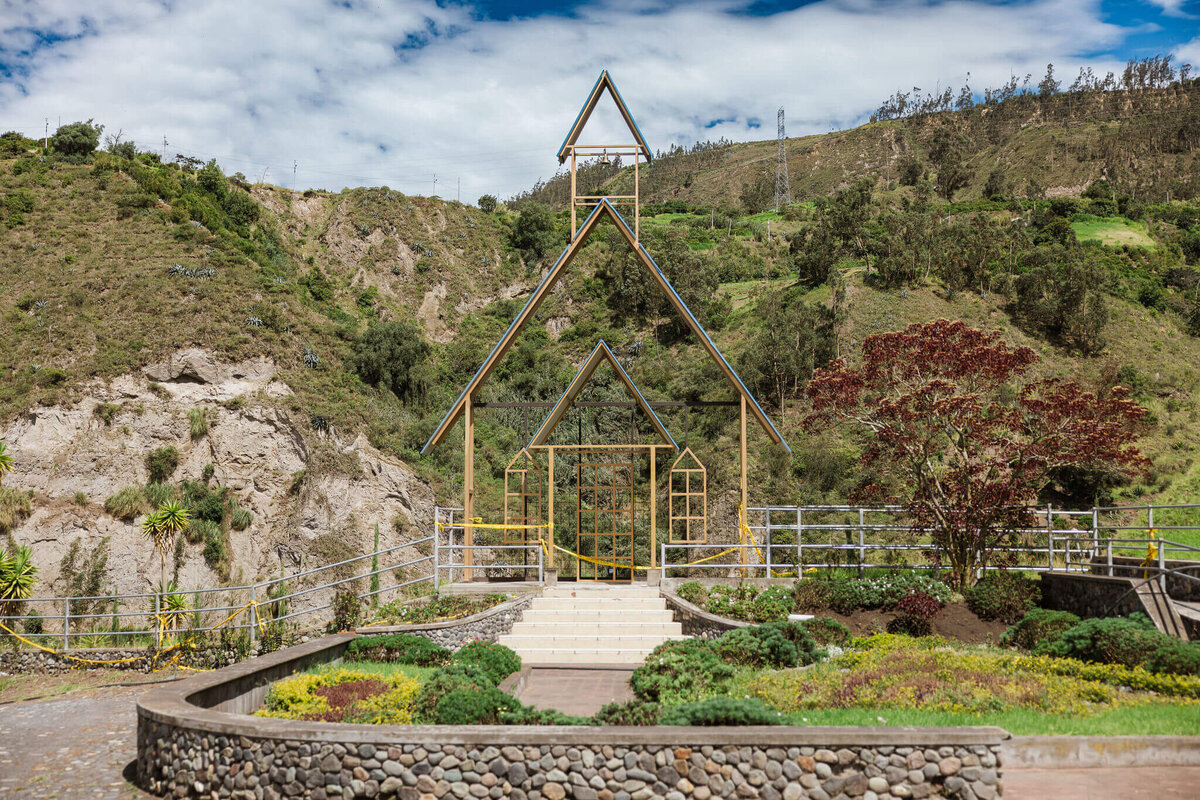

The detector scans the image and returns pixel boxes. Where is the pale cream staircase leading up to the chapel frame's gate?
[498,584,684,667]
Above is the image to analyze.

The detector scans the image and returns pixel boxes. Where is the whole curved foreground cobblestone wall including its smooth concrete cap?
[137,636,1008,800]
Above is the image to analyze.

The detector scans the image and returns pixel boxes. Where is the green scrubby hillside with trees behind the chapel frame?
[0,77,1200,534]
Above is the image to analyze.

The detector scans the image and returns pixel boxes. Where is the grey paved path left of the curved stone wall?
[0,686,163,800]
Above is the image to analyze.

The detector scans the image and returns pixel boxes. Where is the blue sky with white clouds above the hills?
[0,0,1200,201]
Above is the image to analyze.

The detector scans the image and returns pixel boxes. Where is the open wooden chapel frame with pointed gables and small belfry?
[421,71,791,581]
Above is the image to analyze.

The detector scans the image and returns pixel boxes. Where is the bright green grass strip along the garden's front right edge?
[768,703,1200,736]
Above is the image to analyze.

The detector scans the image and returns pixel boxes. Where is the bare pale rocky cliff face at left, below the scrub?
[0,349,433,606]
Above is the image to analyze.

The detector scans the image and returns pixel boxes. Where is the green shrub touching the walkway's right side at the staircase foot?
[629,639,733,704]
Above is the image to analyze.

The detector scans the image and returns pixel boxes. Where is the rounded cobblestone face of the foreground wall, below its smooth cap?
[138,717,1001,800]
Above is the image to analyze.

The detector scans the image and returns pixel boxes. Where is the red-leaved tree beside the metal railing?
[805,319,1148,587]
